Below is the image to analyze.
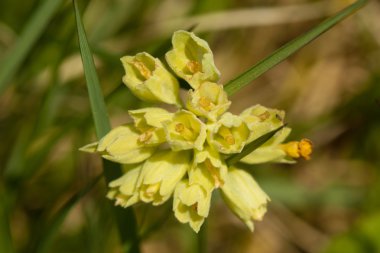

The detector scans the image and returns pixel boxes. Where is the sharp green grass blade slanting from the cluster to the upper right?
[224,0,367,96]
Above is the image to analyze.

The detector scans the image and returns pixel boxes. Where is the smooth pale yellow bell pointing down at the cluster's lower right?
[221,168,269,231]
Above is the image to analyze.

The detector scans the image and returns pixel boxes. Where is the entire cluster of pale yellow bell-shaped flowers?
[81,31,311,232]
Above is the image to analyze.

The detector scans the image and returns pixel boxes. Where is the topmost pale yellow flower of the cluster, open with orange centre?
[166,30,220,89]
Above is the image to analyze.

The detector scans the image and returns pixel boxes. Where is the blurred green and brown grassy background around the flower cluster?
[0,0,380,253]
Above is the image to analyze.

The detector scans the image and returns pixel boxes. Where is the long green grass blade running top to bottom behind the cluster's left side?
[73,0,139,252]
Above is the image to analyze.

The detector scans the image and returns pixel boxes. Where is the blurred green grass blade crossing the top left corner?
[0,0,63,94]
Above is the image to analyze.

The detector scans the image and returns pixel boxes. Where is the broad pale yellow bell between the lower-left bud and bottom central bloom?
[137,150,191,205]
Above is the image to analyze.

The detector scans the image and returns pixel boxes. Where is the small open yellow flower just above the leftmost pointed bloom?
[128,107,173,146]
